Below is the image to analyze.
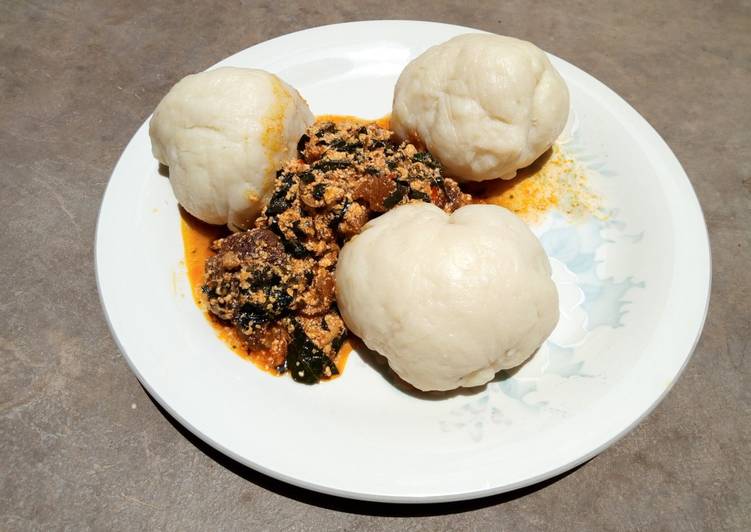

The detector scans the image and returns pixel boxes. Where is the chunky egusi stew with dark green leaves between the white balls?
[203,121,470,383]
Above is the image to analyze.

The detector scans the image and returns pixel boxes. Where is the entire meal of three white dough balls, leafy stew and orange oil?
[156,34,584,390]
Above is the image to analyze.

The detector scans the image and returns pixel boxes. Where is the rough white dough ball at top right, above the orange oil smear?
[391,33,569,181]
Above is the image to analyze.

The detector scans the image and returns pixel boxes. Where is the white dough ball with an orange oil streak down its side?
[149,68,314,230]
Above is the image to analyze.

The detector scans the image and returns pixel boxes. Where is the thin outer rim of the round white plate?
[94,20,712,504]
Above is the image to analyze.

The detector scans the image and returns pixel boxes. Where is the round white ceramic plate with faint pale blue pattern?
[96,21,710,502]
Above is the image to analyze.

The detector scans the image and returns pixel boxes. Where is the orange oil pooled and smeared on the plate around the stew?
[180,115,598,375]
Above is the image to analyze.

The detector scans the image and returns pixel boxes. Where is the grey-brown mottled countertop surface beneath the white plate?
[0,0,751,530]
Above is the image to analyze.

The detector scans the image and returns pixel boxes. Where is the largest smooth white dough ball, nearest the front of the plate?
[336,203,558,391]
